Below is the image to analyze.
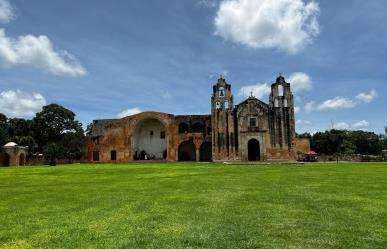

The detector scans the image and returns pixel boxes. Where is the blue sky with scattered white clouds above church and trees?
[0,0,387,133]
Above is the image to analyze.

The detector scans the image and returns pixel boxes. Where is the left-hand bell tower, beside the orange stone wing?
[211,76,235,161]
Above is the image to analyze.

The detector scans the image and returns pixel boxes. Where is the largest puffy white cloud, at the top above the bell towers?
[214,0,320,54]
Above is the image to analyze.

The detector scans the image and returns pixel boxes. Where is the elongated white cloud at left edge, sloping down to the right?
[0,29,86,77]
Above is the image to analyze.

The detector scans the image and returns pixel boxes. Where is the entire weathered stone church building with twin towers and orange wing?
[86,76,308,162]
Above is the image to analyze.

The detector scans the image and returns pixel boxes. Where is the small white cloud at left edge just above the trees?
[0,90,47,118]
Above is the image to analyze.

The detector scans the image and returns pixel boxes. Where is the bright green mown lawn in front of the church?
[0,163,387,249]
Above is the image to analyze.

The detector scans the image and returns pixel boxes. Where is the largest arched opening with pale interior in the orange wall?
[133,118,167,160]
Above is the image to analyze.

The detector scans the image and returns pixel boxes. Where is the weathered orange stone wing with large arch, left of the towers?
[86,112,211,162]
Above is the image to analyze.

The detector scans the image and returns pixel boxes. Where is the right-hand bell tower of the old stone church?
[269,75,296,151]
